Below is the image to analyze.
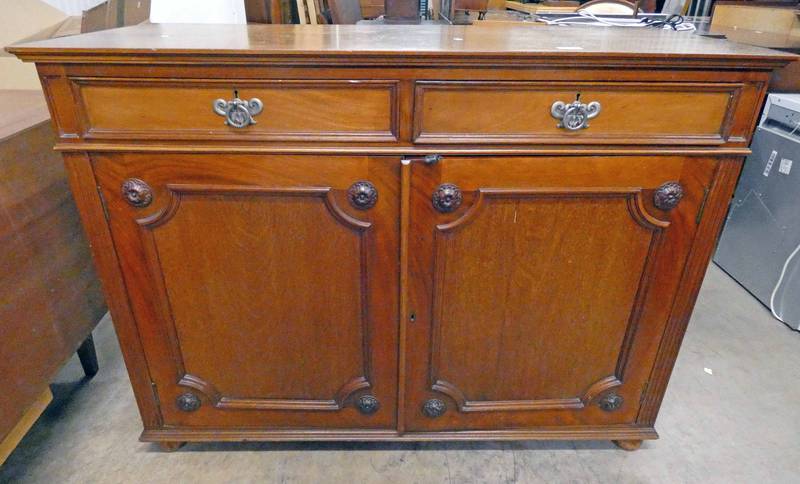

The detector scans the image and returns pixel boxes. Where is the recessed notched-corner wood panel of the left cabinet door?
[148,185,370,409]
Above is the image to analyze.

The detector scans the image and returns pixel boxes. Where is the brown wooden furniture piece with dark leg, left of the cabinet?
[0,90,106,464]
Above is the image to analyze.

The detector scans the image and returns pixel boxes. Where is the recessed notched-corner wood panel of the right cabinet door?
[432,189,664,411]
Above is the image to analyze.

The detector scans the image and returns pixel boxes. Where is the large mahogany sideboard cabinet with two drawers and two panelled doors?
[11,25,791,449]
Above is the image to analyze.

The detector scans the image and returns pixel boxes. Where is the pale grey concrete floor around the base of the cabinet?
[0,266,800,484]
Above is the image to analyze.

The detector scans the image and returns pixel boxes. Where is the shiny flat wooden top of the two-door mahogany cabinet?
[8,24,793,64]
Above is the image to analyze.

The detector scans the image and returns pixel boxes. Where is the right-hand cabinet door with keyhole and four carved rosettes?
[404,157,716,431]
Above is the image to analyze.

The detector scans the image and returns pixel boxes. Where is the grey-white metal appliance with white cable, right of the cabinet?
[714,94,800,329]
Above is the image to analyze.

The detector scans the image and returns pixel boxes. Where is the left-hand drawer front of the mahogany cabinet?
[72,78,397,142]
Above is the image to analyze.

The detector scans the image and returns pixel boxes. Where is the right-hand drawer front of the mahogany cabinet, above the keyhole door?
[414,81,749,145]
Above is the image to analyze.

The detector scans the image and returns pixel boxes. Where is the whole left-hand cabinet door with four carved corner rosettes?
[92,154,399,429]
